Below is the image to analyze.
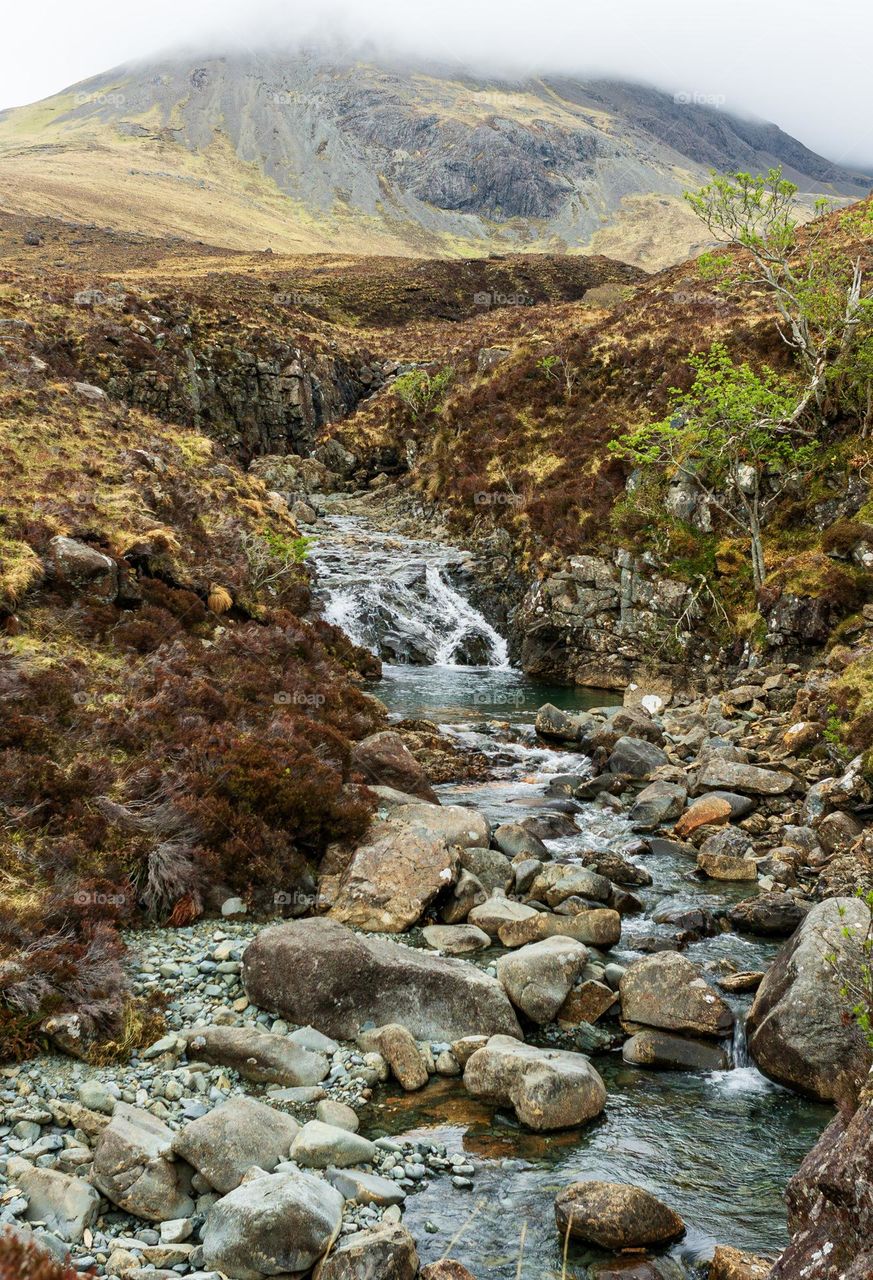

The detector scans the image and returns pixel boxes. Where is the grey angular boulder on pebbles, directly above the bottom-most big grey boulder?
[173,1098,300,1196]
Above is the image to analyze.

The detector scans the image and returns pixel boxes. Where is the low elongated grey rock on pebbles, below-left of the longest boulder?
[182,1019,328,1088]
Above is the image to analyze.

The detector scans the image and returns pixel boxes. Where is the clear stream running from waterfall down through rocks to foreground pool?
[314,517,832,1280]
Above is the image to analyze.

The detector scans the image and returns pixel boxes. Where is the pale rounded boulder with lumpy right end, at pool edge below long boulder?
[463,1036,607,1130]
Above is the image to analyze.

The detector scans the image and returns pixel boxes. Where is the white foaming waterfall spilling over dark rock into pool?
[312,517,509,671]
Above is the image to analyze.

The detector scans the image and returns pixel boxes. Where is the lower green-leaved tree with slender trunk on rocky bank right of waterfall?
[609,343,815,588]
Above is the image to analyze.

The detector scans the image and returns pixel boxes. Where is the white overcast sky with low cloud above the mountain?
[0,0,873,168]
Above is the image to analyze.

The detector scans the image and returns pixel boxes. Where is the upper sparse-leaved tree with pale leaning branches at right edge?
[685,169,873,430]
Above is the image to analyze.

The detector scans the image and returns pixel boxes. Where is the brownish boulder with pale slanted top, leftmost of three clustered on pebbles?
[91,1102,195,1222]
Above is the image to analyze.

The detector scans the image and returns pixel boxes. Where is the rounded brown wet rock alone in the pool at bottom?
[554,1181,685,1249]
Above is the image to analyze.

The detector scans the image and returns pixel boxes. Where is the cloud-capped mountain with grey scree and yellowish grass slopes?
[0,51,873,269]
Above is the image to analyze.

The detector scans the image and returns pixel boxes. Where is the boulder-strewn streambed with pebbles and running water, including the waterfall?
[0,512,869,1280]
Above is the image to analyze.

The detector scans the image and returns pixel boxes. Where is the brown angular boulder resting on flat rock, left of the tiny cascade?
[618,951,733,1036]
